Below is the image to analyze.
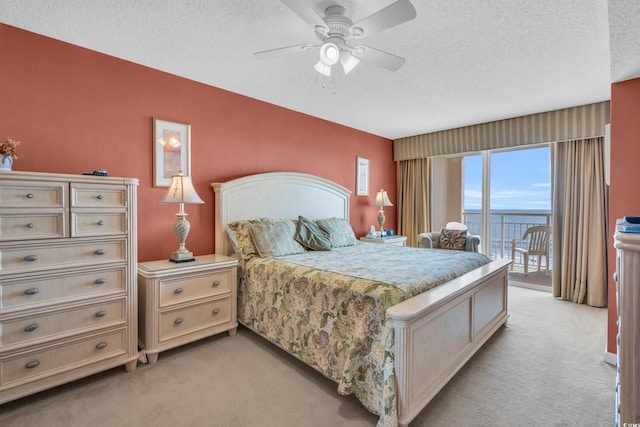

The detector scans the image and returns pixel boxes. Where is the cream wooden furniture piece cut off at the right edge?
[614,226,640,426]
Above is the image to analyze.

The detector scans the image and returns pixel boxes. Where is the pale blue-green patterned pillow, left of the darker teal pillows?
[251,221,304,258]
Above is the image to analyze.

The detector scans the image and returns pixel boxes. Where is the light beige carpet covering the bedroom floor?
[0,287,615,427]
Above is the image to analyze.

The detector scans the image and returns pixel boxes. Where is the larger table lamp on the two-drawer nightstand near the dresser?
[160,171,204,262]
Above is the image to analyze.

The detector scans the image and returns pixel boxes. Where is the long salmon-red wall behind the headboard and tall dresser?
[0,24,396,261]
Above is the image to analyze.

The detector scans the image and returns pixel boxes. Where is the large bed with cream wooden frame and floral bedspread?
[212,172,510,427]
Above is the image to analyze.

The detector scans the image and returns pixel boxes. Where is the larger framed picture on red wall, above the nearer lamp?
[153,117,191,187]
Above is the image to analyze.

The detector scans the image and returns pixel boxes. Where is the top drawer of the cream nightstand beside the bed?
[160,269,232,307]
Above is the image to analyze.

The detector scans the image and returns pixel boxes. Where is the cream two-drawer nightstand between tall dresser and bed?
[138,255,238,363]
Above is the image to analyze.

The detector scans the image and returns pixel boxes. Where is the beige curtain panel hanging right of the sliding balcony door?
[552,137,607,307]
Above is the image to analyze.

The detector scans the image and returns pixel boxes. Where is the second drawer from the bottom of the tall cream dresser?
[0,298,126,347]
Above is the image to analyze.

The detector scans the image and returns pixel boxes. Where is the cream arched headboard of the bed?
[211,172,351,255]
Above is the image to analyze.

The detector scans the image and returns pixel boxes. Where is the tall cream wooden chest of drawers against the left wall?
[0,171,138,403]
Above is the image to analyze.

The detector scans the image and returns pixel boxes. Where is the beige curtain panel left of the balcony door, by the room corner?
[397,158,431,246]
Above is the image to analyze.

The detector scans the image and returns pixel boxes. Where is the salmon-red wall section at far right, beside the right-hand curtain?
[607,79,640,353]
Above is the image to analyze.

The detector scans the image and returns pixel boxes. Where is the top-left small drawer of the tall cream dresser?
[0,180,67,209]
